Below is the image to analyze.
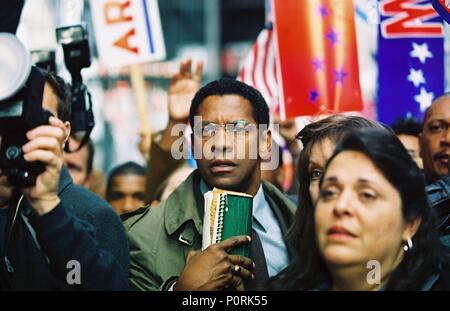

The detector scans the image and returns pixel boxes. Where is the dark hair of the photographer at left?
[44,69,72,122]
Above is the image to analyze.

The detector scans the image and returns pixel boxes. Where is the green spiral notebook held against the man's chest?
[202,188,253,257]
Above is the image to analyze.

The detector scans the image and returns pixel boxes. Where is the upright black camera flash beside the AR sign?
[56,24,95,148]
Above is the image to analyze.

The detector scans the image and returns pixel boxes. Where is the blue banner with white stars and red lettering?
[377,0,444,124]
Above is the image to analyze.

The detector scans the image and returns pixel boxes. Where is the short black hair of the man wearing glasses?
[189,78,270,127]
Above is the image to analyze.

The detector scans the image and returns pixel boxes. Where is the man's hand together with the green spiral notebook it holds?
[174,188,254,291]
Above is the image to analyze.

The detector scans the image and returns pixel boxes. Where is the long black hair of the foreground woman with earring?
[269,129,448,290]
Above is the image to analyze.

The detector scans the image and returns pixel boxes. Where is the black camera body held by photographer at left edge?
[0,67,51,188]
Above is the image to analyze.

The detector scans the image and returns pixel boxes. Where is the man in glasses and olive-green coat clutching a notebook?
[125,79,295,290]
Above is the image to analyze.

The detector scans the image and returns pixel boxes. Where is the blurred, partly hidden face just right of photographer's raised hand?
[64,138,89,186]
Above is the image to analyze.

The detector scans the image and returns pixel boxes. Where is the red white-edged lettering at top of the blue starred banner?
[380,0,444,39]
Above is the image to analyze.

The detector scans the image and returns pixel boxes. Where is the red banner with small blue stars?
[272,0,362,118]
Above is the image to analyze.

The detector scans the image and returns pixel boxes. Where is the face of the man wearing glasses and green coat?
[193,95,271,194]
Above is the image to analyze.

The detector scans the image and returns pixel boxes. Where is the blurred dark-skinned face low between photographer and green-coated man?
[107,174,145,215]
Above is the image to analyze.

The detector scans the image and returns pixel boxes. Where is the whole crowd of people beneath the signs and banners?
[0,56,450,291]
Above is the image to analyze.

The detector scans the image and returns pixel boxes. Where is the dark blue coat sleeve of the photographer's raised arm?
[31,203,129,290]
